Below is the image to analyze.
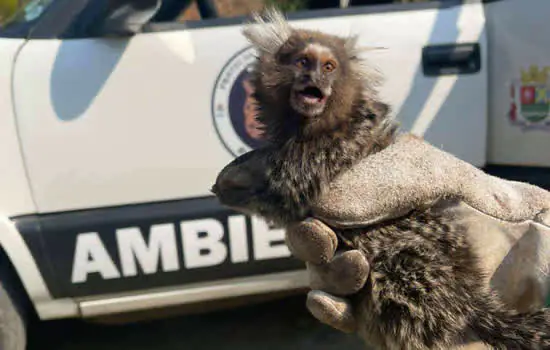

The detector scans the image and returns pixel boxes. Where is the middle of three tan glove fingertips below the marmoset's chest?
[306,250,370,296]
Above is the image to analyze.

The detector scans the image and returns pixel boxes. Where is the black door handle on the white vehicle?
[422,43,481,76]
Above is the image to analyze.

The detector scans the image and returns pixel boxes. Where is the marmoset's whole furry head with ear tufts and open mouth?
[243,11,382,143]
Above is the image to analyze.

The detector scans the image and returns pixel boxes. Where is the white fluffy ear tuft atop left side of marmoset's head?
[242,7,292,55]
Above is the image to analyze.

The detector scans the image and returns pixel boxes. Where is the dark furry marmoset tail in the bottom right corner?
[472,305,550,350]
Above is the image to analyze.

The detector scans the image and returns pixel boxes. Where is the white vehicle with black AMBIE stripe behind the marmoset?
[0,0,550,350]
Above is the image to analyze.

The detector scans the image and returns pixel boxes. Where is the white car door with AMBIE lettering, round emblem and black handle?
[10,0,487,313]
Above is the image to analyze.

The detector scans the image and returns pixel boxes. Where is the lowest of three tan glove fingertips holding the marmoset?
[306,290,357,333]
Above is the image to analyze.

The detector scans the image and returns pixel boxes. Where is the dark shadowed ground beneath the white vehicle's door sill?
[29,296,364,350]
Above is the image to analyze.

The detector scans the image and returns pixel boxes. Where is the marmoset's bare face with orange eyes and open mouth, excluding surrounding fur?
[289,43,339,118]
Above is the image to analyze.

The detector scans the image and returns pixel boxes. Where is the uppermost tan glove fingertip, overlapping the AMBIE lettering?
[285,219,338,264]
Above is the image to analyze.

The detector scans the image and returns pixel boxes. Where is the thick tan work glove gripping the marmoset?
[213,134,550,346]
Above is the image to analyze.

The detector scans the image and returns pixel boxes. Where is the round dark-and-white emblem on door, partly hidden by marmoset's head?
[212,47,268,157]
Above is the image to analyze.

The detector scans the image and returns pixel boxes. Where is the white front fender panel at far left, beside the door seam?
[0,38,78,319]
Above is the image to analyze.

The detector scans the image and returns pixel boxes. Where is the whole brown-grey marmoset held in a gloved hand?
[212,9,550,350]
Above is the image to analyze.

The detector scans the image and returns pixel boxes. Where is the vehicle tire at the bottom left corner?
[0,260,27,350]
